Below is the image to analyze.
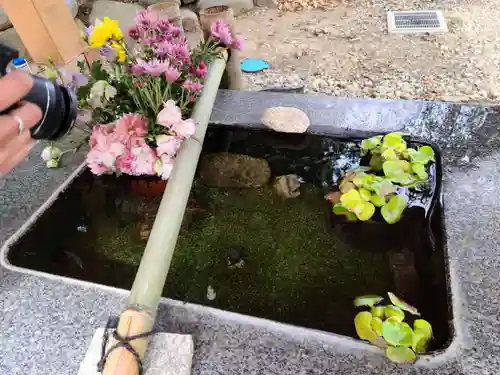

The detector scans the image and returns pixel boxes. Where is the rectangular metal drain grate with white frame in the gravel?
[387,10,448,33]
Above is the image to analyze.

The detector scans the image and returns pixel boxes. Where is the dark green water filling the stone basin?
[9,130,454,346]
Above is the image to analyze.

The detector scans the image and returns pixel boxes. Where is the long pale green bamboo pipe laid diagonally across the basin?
[103,51,227,375]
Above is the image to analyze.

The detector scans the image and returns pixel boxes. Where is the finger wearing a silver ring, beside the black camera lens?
[0,102,42,147]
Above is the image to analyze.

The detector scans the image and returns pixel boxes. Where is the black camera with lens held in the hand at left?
[0,43,78,140]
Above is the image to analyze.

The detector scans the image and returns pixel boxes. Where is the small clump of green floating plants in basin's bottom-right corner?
[354,292,432,364]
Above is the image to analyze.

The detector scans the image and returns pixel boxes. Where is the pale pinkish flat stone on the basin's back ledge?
[261,107,311,133]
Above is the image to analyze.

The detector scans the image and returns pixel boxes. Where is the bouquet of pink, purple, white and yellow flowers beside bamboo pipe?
[42,10,242,180]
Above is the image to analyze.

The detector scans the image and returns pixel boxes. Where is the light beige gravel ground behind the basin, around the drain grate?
[237,0,500,103]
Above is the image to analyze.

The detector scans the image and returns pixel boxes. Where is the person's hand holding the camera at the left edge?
[0,72,42,176]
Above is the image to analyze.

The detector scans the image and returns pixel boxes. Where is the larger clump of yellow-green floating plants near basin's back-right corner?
[325,133,435,224]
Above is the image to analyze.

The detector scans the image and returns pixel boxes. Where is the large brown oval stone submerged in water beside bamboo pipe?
[199,152,271,188]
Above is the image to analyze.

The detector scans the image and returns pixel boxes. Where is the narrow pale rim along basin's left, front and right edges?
[0,156,465,367]
